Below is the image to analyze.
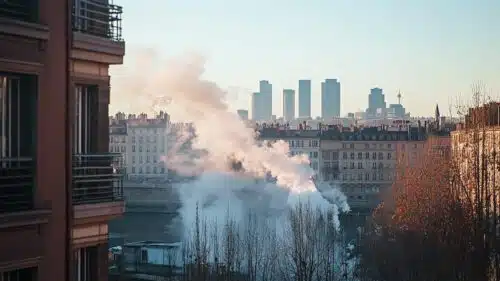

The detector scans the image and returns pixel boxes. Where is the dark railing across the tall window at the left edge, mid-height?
[0,158,35,213]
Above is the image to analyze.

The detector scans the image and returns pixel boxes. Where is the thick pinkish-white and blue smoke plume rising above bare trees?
[114,52,349,236]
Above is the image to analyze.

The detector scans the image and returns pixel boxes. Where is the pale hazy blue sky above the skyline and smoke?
[111,0,500,116]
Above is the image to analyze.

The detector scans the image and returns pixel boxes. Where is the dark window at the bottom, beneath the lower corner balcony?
[73,247,99,281]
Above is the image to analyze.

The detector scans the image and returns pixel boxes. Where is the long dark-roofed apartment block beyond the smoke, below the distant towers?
[258,120,449,211]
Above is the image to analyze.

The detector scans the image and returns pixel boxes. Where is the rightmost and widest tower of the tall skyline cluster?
[321,79,340,120]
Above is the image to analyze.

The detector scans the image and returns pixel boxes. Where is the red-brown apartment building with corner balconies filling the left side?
[0,0,125,280]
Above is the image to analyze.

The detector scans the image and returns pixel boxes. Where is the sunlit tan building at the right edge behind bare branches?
[451,102,500,234]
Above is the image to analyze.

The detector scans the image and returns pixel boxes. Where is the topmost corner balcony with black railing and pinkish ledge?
[72,0,125,64]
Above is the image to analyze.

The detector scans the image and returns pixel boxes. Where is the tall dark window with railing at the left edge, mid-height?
[0,73,37,212]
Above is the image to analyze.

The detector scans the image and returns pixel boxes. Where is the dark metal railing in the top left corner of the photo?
[0,0,38,22]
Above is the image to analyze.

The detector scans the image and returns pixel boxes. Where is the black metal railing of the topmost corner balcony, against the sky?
[72,0,123,42]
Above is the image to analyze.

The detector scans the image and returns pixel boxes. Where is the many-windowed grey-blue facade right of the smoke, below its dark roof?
[321,127,427,209]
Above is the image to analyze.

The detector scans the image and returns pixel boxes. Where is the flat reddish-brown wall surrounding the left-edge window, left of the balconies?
[0,0,70,280]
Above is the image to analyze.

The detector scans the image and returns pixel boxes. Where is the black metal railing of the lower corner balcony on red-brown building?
[72,153,125,205]
